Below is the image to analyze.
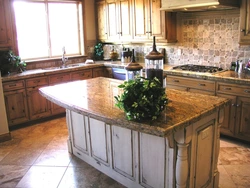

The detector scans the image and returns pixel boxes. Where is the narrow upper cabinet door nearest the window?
[96,1,108,40]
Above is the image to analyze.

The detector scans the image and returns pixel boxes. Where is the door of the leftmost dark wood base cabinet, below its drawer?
[4,89,29,126]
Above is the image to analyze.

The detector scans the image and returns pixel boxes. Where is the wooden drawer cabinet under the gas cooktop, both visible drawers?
[167,75,215,95]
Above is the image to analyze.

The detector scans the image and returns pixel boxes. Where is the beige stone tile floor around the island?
[0,118,250,188]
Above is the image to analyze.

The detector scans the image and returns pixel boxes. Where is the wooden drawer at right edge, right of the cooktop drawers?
[217,82,250,97]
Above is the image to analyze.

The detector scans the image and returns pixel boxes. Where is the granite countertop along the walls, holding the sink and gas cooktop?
[2,61,250,84]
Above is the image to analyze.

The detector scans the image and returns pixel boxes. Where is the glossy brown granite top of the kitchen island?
[40,77,229,137]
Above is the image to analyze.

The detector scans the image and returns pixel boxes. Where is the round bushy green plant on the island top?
[115,77,168,121]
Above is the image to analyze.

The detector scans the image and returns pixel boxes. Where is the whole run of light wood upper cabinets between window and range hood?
[96,0,176,42]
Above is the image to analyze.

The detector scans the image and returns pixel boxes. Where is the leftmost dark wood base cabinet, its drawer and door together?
[3,80,29,126]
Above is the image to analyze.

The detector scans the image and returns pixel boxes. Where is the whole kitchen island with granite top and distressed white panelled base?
[39,77,229,188]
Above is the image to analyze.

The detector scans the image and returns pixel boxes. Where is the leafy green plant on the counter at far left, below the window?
[0,50,26,75]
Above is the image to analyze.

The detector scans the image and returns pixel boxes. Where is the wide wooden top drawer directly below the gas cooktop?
[167,76,215,91]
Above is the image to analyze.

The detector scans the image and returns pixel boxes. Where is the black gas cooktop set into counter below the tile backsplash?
[173,64,223,73]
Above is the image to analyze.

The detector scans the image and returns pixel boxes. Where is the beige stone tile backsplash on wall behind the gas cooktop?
[129,10,250,68]
